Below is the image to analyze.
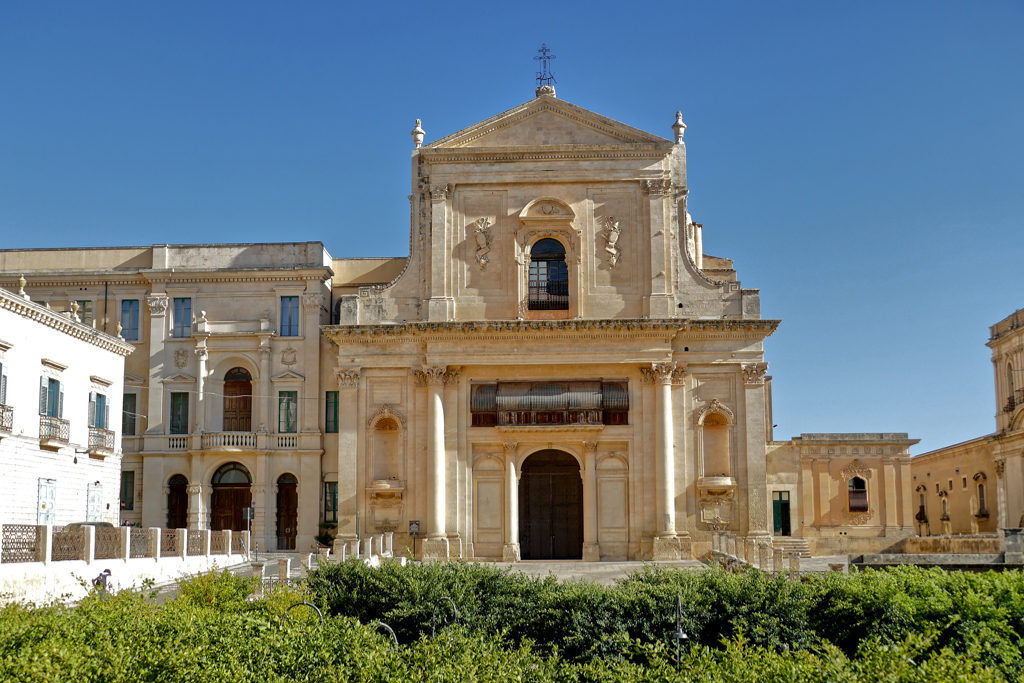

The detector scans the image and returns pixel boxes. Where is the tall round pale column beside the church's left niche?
[422,366,449,560]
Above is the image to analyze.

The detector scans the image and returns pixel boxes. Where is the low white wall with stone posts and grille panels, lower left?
[0,524,249,604]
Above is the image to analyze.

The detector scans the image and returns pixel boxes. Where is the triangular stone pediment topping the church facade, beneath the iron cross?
[424,95,673,150]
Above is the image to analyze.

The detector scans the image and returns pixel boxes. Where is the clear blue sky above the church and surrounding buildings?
[0,0,1024,453]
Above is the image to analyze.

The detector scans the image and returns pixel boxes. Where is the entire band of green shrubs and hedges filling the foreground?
[0,562,1024,683]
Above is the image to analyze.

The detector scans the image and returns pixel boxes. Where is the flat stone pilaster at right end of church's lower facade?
[741,362,770,537]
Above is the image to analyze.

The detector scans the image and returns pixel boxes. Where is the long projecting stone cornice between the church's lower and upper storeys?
[321,318,781,343]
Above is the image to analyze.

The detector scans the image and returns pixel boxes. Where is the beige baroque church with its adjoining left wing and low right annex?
[0,85,916,561]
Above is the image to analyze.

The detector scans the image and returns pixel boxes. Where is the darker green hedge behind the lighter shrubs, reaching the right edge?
[308,561,1024,678]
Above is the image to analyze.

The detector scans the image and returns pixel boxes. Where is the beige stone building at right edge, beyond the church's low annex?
[911,309,1024,536]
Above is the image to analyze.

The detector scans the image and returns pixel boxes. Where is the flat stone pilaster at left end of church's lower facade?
[334,368,359,555]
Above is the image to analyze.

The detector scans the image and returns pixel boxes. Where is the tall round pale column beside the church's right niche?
[651,362,679,560]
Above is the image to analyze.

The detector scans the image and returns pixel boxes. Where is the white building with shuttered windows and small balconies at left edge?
[0,280,134,524]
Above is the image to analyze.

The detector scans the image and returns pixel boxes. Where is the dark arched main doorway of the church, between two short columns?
[519,451,583,560]
